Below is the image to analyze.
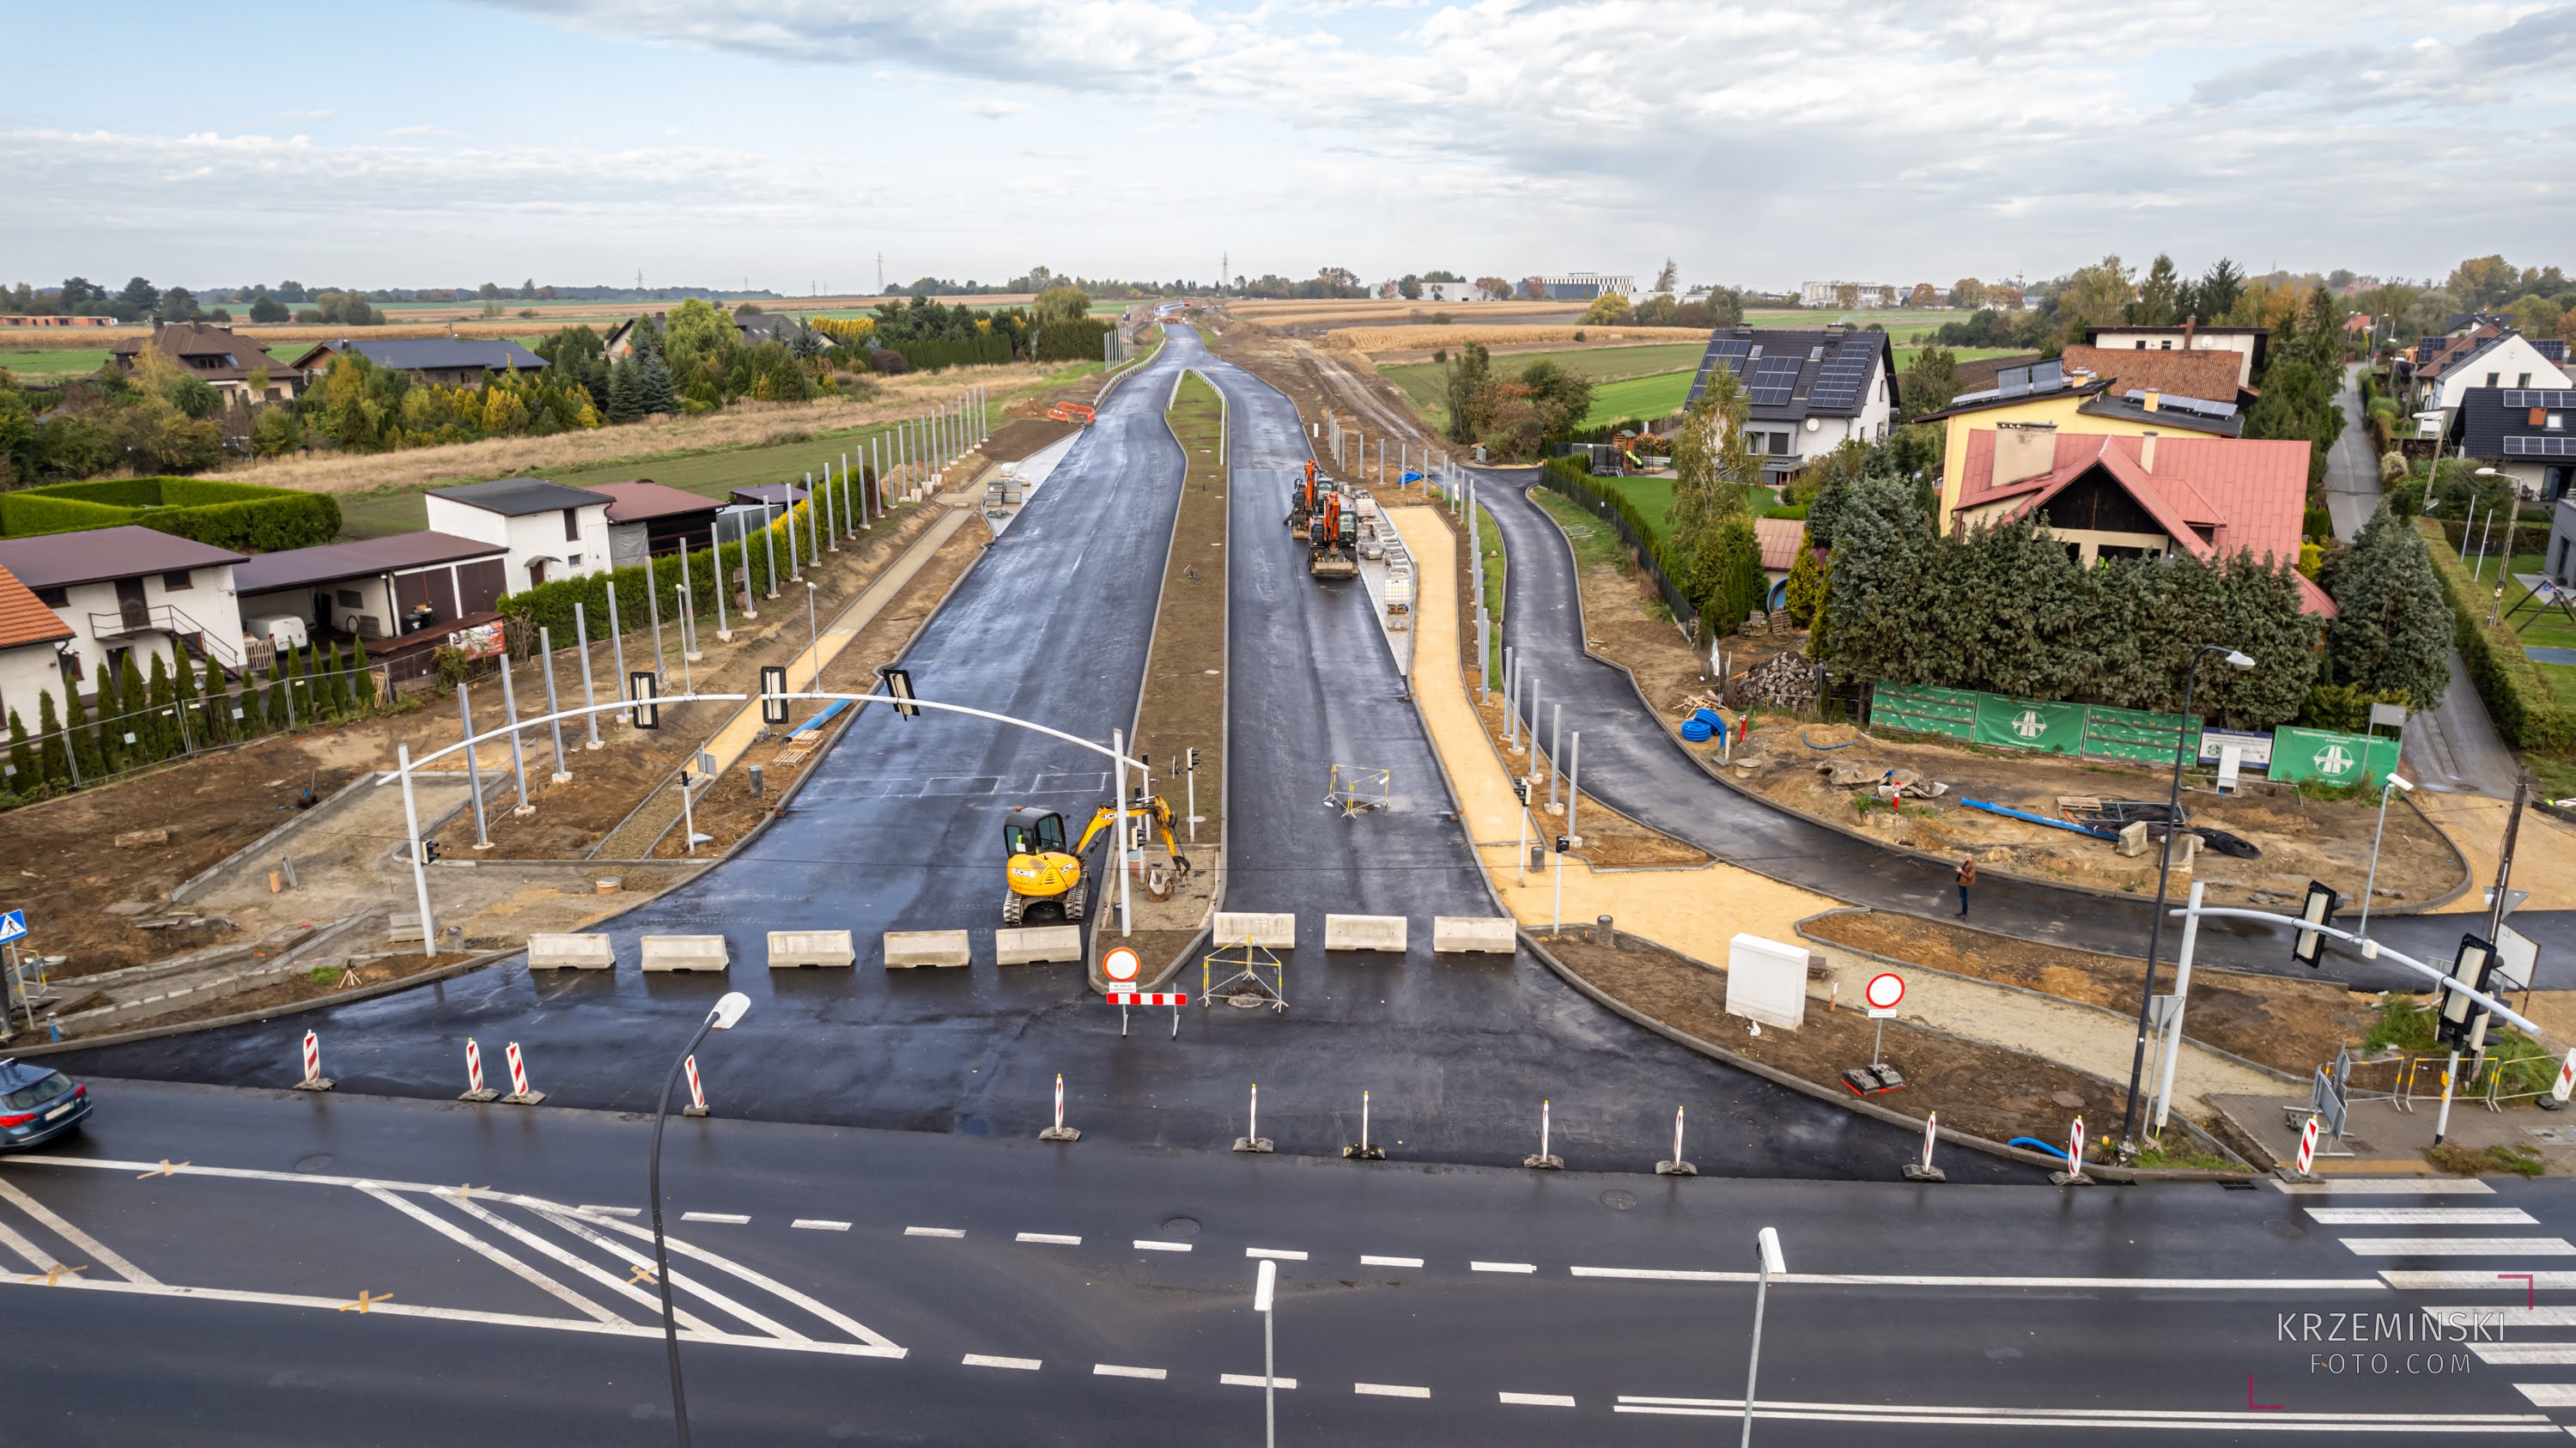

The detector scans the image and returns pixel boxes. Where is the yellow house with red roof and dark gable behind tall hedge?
[1950,425,2334,618]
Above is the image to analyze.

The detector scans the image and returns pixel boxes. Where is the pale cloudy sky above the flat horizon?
[0,0,2576,291]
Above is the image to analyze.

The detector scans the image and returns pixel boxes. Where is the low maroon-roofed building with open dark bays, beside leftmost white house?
[232,533,507,639]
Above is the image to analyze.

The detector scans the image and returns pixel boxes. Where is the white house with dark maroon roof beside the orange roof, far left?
[0,523,247,685]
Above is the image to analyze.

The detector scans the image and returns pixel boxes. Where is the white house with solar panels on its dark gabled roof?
[1690,327,1896,482]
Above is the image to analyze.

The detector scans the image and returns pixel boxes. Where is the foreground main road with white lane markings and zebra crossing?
[15,1082,2576,1448]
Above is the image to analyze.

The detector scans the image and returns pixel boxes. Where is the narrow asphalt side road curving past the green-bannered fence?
[1476,469,2576,989]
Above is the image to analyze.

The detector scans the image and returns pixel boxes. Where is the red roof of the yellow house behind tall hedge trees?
[1958,428,2334,618]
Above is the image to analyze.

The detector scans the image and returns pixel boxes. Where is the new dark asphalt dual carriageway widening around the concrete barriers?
[62,327,1999,1183]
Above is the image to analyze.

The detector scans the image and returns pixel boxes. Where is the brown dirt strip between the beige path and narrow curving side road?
[1803,910,2375,1074]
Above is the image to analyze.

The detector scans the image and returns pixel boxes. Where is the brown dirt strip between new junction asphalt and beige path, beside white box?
[1548,935,2120,1141]
